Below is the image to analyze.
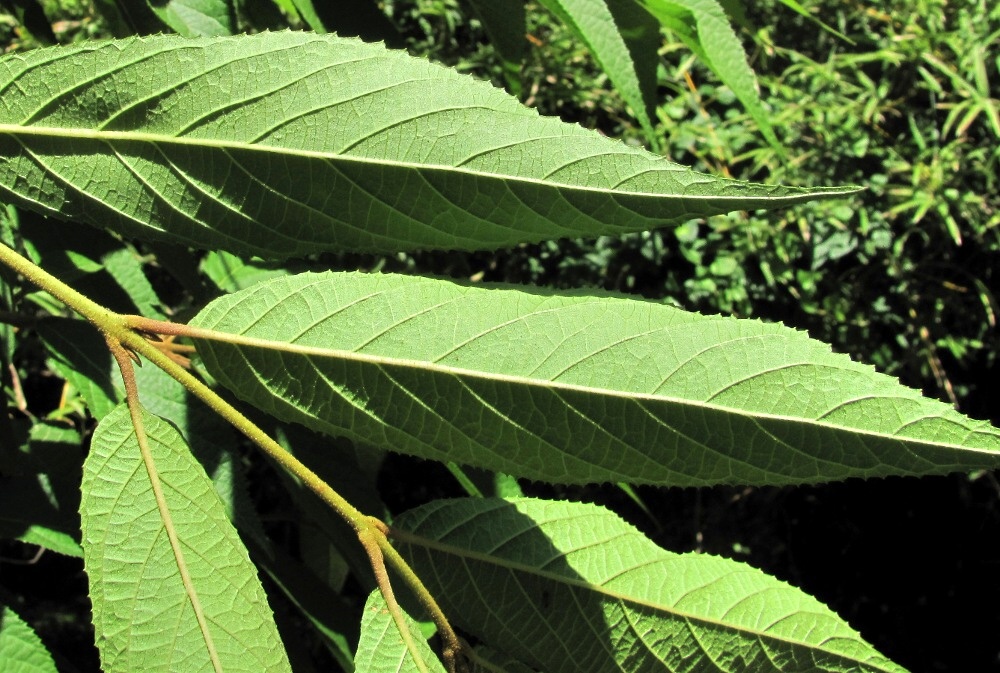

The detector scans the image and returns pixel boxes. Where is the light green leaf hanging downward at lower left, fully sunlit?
[80,406,290,673]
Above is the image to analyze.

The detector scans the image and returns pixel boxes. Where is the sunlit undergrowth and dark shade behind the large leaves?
[0,0,1000,671]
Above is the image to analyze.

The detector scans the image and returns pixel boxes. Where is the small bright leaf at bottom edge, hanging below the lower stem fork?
[354,591,444,673]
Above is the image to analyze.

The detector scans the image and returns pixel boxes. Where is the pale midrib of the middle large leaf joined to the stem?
[185,327,997,454]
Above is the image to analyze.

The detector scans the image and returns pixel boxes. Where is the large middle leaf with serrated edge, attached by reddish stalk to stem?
[192,273,1000,485]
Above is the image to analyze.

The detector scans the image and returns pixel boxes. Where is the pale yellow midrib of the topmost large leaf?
[0,124,859,203]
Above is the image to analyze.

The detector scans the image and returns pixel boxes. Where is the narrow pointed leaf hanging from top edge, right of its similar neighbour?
[639,0,785,154]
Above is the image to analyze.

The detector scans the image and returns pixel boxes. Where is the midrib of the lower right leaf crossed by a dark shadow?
[390,526,893,671]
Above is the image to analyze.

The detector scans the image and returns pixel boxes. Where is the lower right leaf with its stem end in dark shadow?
[392,499,902,673]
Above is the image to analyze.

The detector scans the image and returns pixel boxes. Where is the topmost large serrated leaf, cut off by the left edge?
[0,32,851,257]
